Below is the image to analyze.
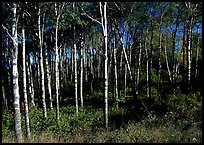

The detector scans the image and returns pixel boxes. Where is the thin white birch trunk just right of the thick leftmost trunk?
[22,13,30,137]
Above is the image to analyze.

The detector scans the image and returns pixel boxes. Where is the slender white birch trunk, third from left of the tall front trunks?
[38,8,47,118]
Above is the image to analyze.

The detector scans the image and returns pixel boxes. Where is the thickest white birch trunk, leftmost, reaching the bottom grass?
[12,3,23,143]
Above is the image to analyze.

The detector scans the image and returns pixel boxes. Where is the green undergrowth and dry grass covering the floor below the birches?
[2,104,202,143]
